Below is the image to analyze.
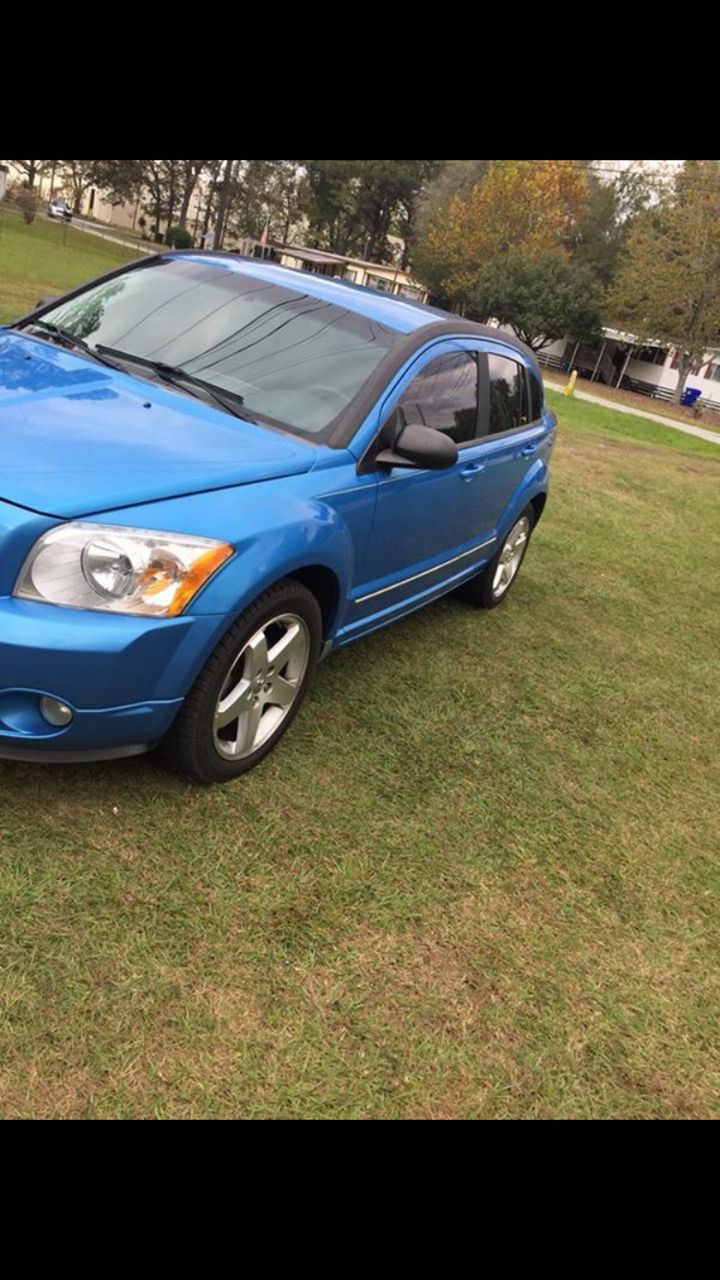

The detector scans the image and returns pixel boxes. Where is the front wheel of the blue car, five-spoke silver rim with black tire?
[159,577,323,785]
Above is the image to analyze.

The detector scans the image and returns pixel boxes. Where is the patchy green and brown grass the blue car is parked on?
[0,235,720,1117]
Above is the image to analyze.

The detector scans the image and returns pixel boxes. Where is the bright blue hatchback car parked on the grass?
[0,251,555,783]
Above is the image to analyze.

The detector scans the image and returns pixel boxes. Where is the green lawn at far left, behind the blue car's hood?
[0,204,144,324]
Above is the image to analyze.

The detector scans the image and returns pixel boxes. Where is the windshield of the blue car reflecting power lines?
[32,257,400,435]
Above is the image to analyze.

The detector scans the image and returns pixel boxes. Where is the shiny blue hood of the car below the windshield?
[0,329,316,518]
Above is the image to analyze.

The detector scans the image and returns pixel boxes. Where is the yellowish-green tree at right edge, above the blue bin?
[609,161,720,403]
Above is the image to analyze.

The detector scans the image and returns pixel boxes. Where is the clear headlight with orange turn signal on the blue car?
[13,524,233,618]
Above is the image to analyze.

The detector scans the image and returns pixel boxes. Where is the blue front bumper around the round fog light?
[0,596,227,762]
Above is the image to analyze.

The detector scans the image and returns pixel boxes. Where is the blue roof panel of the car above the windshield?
[168,250,468,337]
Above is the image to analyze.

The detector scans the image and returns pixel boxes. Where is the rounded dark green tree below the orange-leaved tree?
[470,250,602,351]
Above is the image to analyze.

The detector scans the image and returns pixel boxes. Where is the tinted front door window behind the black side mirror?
[395,352,478,444]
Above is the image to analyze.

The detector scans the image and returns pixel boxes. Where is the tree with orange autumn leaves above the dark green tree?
[413,160,587,307]
